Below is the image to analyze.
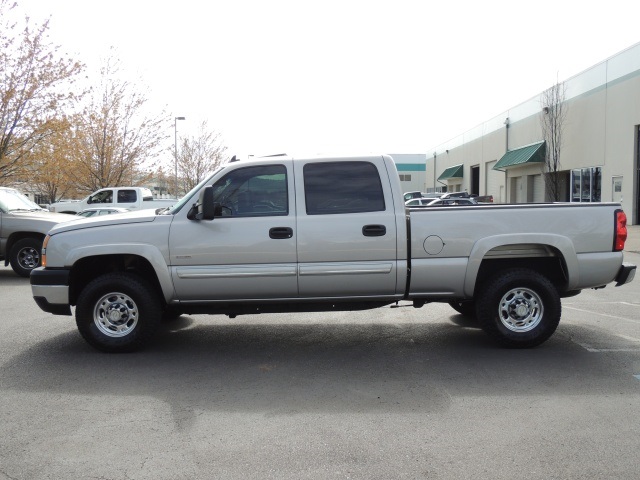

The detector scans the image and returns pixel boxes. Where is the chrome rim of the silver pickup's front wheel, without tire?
[93,292,138,337]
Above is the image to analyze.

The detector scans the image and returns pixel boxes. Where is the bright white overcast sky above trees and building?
[18,0,640,160]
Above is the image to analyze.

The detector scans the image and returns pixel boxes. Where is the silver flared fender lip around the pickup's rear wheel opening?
[464,233,580,297]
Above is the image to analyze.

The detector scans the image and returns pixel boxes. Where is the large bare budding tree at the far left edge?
[0,0,83,183]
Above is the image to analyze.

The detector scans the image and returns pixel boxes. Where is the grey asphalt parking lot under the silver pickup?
[0,227,640,480]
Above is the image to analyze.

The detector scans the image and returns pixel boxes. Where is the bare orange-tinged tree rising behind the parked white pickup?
[71,56,169,192]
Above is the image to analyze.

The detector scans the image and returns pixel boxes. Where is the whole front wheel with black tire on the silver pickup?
[76,272,162,353]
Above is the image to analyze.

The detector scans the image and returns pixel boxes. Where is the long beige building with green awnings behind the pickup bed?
[424,43,640,224]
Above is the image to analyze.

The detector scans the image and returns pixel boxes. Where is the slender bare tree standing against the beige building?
[540,82,567,202]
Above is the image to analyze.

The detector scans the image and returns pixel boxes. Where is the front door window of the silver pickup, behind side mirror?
[213,165,289,217]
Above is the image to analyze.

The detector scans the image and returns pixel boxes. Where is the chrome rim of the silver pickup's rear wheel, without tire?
[498,288,544,333]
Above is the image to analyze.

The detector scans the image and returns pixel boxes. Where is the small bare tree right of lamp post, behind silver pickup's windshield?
[178,120,227,194]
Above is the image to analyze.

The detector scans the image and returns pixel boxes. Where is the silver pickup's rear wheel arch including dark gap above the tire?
[464,234,579,298]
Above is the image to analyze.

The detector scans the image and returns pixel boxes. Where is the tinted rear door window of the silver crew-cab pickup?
[304,162,385,215]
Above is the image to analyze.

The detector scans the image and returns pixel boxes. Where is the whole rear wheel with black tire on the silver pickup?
[476,268,562,348]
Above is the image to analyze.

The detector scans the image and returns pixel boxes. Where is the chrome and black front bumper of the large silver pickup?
[30,267,71,315]
